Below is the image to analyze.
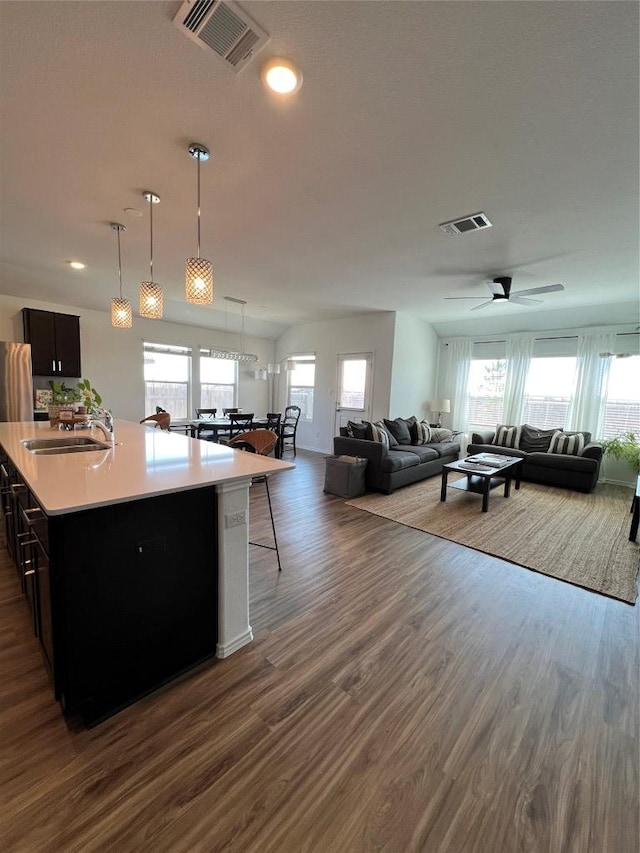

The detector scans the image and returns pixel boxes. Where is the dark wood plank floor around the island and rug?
[0,452,640,853]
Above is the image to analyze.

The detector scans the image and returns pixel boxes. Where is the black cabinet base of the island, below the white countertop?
[0,448,218,725]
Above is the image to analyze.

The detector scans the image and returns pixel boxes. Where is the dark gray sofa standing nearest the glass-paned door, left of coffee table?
[333,418,460,495]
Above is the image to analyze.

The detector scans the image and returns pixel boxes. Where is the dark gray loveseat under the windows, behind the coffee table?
[467,424,602,492]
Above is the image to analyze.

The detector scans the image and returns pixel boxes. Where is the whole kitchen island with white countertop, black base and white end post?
[0,420,294,725]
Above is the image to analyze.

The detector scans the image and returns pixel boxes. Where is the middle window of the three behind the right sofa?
[523,357,577,429]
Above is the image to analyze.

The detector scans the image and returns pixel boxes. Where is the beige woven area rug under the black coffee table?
[347,475,640,604]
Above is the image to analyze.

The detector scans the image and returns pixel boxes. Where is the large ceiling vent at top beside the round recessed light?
[173,0,269,73]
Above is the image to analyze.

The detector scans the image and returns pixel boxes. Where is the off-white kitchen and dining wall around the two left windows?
[0,295,275,421]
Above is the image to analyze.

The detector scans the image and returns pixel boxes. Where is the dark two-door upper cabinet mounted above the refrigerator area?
[22,308,82,377]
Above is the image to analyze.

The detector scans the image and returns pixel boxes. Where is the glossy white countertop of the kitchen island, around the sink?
[0,420,295,515]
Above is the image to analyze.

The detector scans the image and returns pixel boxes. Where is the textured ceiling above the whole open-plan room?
[0,0,639,337]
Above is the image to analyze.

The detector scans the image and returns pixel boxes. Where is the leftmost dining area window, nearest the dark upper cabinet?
[144,343,191,420]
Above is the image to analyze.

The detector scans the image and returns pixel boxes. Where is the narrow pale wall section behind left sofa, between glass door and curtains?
[389,313,438,419]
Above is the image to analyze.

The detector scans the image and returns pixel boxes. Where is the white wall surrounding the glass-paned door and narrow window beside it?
[276,311,395,453]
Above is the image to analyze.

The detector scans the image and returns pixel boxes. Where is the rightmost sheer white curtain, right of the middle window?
[568,334,616,439]
